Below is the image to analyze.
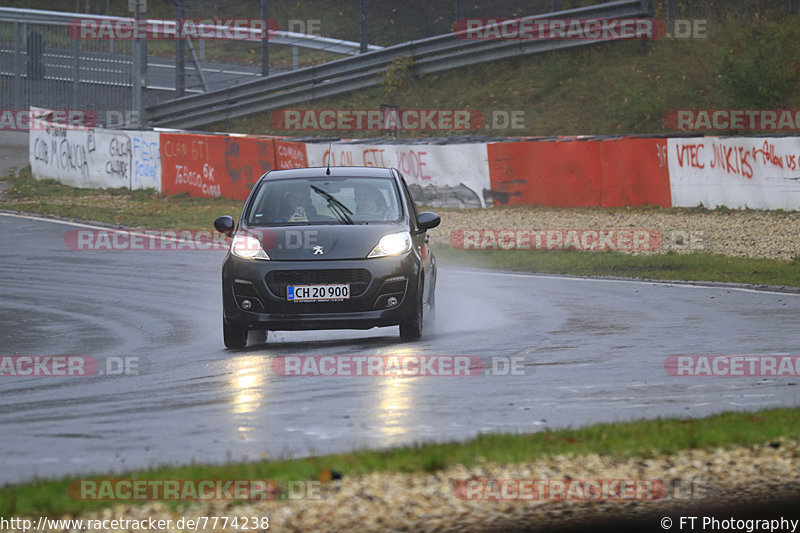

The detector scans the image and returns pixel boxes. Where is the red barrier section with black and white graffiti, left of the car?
[161,133,275,200]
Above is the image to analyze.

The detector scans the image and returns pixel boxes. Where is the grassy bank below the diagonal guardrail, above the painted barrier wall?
[207,10,800,137]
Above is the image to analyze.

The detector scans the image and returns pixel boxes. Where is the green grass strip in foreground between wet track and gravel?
[0,408,800,516]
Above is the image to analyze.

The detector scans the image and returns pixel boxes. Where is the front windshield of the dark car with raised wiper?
[247,176,401,226]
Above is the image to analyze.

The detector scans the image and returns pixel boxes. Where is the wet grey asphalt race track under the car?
[0,211,800,486]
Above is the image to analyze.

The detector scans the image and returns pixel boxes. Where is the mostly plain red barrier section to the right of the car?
[487,138,670,207]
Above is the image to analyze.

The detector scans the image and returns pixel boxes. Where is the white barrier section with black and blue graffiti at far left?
[29,110,161,191]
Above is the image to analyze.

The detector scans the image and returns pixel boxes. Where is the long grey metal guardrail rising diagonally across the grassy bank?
[147,0,655,129]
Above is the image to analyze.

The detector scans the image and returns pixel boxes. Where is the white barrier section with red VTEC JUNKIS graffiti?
[667,137,800,210]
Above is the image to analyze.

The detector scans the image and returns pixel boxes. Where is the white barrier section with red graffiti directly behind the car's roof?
[306,143,491,207]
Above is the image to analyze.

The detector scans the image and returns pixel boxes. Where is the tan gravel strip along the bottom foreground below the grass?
[7,439,800,532]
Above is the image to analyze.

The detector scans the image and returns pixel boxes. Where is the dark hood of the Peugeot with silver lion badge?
[242,224,405,261]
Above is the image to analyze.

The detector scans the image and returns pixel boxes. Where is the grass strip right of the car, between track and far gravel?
[434,245,800,287]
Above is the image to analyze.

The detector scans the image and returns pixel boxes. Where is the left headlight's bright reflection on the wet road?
[231,356,269,440]
